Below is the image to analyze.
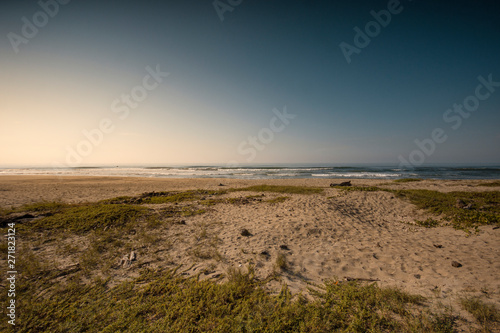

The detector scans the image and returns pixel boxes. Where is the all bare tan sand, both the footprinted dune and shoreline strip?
[0,176,500,326]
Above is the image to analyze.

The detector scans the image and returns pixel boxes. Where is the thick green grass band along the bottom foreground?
[0,266,458,333]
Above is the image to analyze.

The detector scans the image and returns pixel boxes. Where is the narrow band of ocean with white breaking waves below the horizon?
[0,165,500,179]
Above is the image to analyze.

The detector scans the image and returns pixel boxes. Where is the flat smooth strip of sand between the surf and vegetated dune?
[0,175,495,207]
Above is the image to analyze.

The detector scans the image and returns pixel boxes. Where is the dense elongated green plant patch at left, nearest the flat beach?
[22,204,148,233]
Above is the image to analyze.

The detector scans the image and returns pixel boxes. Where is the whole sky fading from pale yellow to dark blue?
[0,0,500,167]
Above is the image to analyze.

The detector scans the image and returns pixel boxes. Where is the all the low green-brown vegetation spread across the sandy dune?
[0,185,500,332]
